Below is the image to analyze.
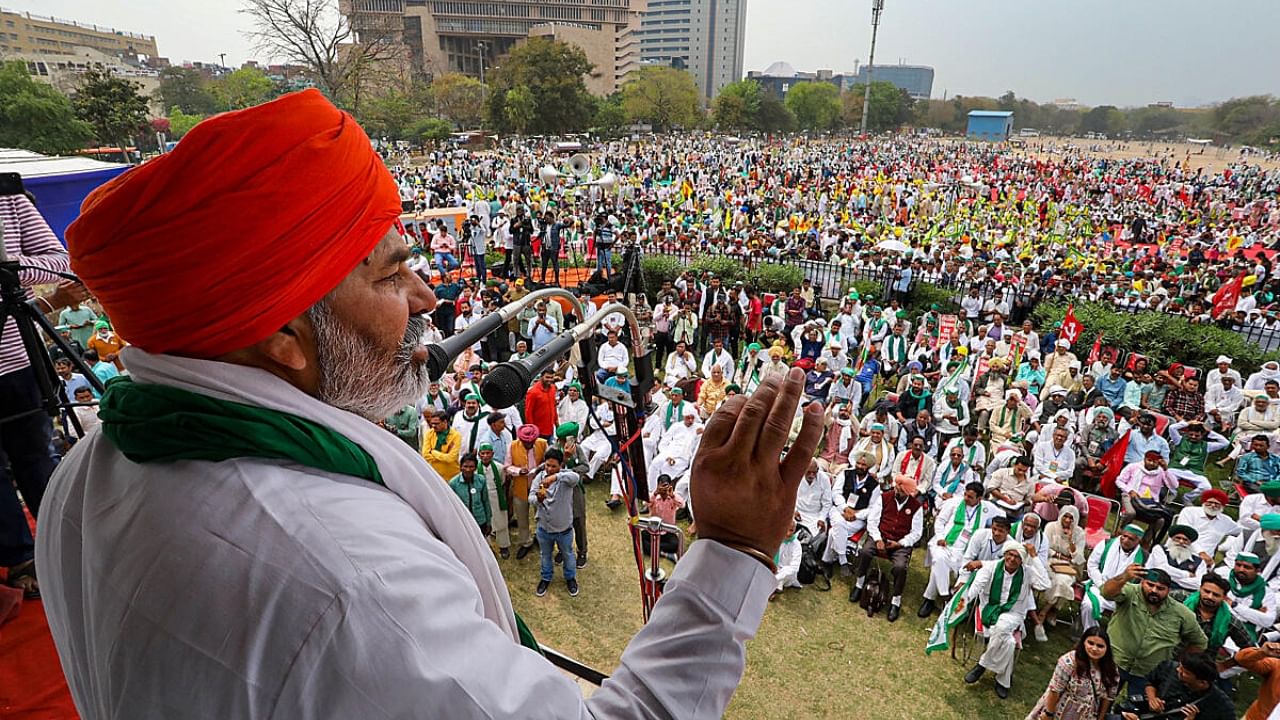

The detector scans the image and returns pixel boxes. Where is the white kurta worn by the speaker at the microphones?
[37,348,774,720]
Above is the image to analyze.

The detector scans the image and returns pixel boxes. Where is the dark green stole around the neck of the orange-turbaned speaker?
[99,377,541,653]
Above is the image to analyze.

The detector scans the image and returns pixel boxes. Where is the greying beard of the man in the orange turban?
[307,300,429,421]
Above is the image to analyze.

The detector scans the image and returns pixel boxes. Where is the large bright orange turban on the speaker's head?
[67,90,401,357]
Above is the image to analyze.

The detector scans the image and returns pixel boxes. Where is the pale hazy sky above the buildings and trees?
[22,0,1280,105]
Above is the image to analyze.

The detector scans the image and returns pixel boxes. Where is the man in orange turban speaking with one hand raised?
[36,90,820,720]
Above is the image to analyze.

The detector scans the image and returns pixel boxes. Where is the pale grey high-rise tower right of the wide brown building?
[640,0,746,99]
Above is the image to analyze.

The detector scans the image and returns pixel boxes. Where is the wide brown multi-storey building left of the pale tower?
[340,0,645,92]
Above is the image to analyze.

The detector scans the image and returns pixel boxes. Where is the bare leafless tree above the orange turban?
[241,0,397,111]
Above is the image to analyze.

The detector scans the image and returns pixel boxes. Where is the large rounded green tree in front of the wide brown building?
[488,37,595,135]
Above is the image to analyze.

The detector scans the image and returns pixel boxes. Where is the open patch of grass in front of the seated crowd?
[509,474,1071,720]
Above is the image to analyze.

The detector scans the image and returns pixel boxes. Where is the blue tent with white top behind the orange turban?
[0,149,131,245]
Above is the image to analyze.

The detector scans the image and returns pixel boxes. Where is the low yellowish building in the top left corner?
[0,8,160,58]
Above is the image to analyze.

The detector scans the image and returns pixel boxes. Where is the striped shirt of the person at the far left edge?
[0,195,70,375]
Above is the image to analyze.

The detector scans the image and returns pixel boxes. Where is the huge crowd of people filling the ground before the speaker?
[15,130,1280,717]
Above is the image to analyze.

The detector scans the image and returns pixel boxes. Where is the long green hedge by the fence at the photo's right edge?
[1032,302,1280,375]
